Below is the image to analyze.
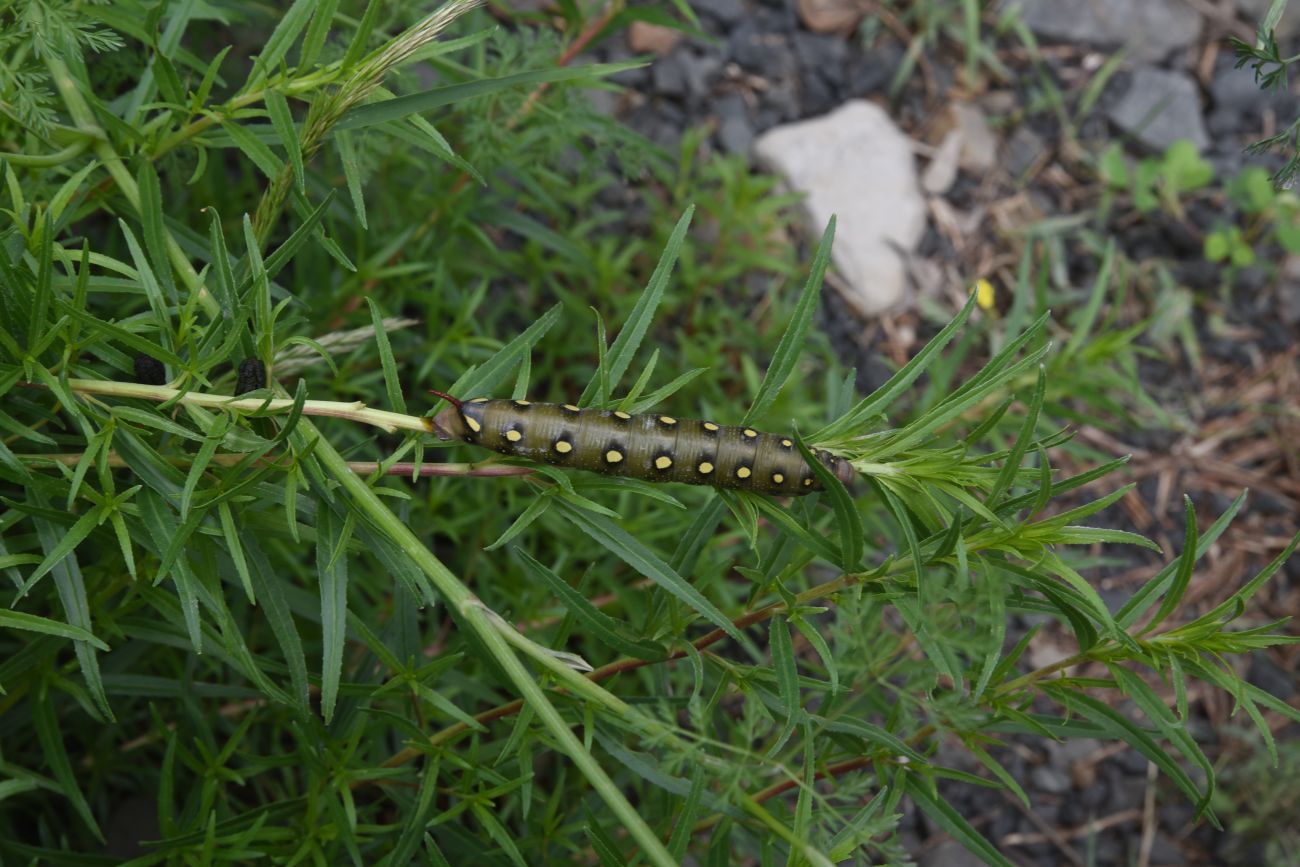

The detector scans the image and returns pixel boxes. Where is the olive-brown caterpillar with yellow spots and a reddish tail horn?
[433,391,857,497]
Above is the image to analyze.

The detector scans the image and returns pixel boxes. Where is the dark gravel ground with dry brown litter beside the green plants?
[577,0,1300,867]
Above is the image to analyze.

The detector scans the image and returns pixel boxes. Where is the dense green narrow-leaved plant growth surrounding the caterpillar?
[0,3,1300,864]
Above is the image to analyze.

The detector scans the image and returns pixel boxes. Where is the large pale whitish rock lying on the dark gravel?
[754,100,926,316]
